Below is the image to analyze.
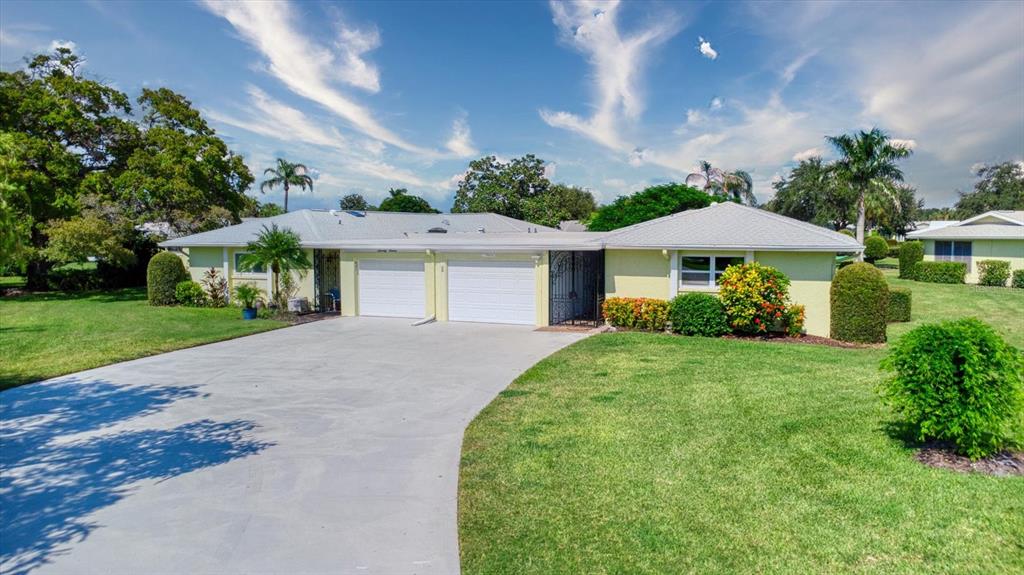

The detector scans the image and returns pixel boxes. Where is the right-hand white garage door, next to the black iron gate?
[449,261,537,325]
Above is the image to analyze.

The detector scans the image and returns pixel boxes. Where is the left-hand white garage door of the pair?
[359,260,426,317]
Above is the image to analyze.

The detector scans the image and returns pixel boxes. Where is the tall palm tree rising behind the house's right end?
[825,128,912,244]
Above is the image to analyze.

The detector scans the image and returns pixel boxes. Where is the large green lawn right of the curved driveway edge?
[459,272,1024,574]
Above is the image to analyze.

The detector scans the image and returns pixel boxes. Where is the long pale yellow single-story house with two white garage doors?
[162,203,862,336]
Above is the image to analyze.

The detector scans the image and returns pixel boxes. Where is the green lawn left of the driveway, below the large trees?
[0,290,287,389]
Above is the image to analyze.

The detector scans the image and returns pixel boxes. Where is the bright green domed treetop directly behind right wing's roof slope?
[588,183,718,231]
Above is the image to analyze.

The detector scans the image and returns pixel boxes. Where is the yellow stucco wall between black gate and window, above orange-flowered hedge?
[604,250,669,300]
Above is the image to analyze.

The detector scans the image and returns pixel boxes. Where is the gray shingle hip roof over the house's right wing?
[604,202,863,252]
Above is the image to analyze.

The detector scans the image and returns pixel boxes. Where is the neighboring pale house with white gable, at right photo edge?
[906,211,1024,283]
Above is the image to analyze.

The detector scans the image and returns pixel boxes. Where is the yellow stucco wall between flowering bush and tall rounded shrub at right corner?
[754,252,836,338]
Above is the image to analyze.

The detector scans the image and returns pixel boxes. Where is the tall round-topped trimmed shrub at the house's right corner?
[831,263,889,344]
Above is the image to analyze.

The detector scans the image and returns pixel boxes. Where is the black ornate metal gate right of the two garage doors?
[549,252,604,325]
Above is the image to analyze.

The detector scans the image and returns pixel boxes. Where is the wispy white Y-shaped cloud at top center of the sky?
[541,1,678,151]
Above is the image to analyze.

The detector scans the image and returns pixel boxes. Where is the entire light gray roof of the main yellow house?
[161,203,863,252]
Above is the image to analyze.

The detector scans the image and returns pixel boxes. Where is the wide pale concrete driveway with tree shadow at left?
[0,318,582,574]
